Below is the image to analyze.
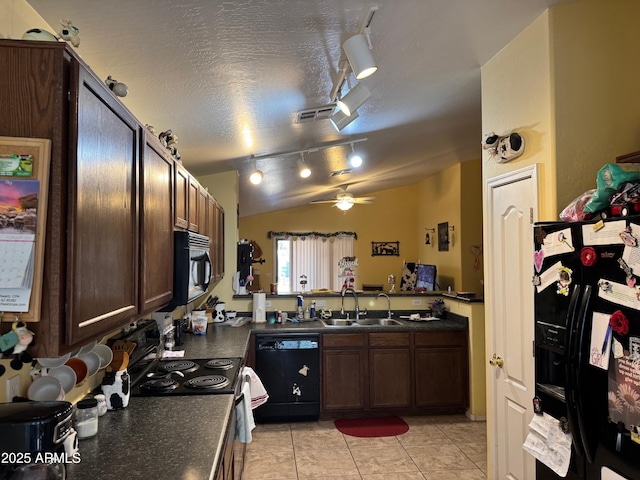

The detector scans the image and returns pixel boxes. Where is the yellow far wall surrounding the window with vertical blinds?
[239,185,418,288]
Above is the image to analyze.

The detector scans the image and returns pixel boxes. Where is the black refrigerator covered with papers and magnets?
[533,216,640,480]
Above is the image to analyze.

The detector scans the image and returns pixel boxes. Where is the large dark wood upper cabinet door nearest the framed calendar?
[66,61,139,344]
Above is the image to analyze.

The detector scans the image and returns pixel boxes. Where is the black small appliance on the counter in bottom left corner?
[0,401,74,480]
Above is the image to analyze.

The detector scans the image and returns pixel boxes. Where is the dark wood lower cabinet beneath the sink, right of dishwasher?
[321,330,469,415]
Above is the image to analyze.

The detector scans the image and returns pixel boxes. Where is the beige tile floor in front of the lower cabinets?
[243,415,487,480]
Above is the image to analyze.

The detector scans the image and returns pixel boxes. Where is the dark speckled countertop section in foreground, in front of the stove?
[67,395,234,480]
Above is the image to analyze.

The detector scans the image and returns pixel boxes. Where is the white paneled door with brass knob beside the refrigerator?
[485,166,538,480]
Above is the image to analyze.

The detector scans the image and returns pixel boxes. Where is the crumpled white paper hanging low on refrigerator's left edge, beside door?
[522,413,571,477]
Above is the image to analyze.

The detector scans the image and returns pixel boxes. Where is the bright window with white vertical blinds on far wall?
[274,235,355,293]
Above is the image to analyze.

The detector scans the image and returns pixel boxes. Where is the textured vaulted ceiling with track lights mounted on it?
[28,0,566,216]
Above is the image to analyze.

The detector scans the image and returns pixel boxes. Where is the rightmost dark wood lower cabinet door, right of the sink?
[415,346,469,409]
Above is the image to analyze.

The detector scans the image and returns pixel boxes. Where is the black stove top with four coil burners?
[131,357,243,397]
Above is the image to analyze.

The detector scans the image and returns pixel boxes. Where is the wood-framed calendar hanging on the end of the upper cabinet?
[0,137,51,322]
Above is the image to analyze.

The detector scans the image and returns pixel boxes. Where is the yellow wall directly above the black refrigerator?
[549,0,640,214]
